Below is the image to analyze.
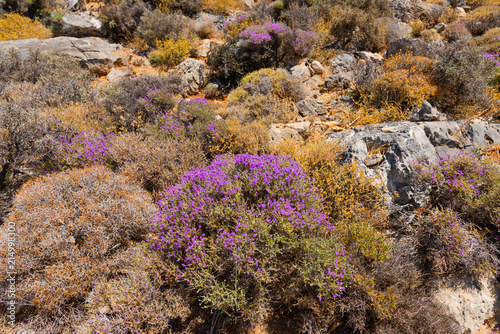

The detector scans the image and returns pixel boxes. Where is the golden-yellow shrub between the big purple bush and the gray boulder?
[270,140,390,260]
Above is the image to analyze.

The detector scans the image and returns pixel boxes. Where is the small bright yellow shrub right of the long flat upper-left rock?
[149,37,193,68]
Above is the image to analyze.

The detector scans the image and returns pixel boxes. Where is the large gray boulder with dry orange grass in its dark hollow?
[327,122,439,207]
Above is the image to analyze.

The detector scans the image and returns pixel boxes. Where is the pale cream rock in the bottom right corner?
[434,277,500,333]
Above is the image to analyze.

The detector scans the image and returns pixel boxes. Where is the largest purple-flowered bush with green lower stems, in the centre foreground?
[151,154,350,322]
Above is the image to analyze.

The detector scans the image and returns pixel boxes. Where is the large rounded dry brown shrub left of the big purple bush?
[0,166,155,323]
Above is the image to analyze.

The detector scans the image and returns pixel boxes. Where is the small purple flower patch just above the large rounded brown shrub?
[60,132,114,167]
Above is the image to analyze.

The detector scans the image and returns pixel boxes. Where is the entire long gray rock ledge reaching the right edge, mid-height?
[327,120,500,207]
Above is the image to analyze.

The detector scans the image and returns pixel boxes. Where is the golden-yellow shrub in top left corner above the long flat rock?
[0,13,51,41]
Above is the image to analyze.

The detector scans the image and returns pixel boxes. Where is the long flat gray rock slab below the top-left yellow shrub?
[0,37,127,75]
